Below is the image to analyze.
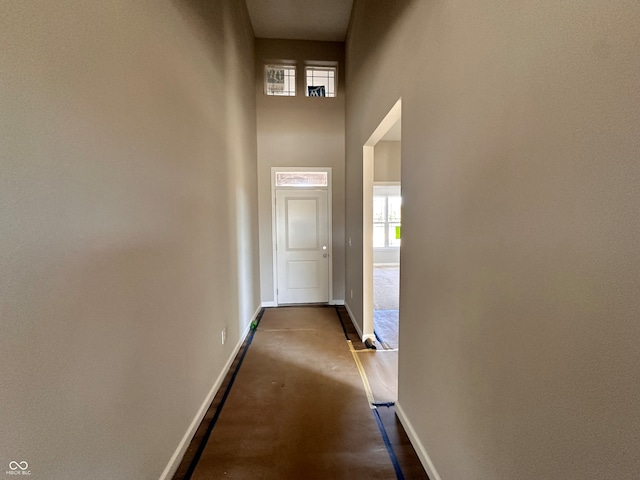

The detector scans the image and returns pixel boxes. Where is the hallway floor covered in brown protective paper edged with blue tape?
[174,307,428,480]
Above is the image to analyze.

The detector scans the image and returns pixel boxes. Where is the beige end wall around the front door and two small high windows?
[255,39,345,304]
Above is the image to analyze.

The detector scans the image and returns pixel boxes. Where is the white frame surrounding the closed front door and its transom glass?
[271,167,333,307]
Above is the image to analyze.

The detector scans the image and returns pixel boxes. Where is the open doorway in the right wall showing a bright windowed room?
[362,100,402,403]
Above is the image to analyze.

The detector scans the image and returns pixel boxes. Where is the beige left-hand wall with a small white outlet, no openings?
[0,0,259,480]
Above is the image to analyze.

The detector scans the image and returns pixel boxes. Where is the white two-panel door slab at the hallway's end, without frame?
[276,189,330,304]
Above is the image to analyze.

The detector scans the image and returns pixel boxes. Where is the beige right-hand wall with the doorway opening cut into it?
[346,0,640,480]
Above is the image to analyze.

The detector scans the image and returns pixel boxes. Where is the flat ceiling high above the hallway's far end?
[246,0,353,42]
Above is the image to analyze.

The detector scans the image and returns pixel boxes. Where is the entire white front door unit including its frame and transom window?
[271,167,332,305]
